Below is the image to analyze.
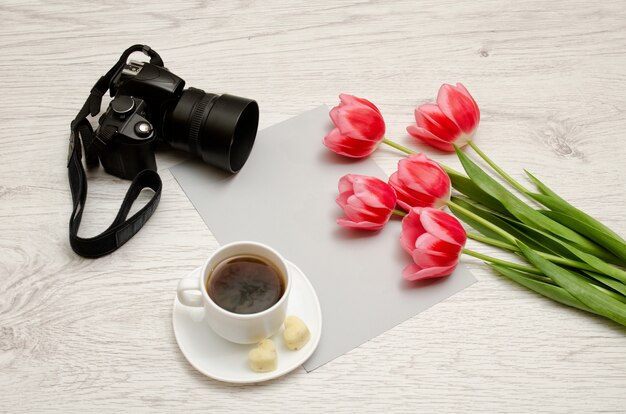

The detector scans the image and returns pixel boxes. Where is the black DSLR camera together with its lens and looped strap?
[67,44,259,257]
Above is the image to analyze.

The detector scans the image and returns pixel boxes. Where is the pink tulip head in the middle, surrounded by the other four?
[389,154,451,210]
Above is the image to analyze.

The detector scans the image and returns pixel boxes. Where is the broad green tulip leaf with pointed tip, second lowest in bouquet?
[517,242,626,326]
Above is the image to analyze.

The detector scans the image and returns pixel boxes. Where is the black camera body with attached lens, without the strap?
[93,61,259,180]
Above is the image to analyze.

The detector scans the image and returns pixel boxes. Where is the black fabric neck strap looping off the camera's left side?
[67,45,163,258]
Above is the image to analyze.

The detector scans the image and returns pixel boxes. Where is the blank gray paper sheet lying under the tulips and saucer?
[171,106,476,371]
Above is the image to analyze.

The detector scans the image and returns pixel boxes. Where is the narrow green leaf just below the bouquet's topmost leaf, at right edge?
[532,200,626,263]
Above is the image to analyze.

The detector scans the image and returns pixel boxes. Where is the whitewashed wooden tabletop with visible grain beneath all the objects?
[0,0,626,413]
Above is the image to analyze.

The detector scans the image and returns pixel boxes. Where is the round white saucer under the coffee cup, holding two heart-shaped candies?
[172,261,322,384]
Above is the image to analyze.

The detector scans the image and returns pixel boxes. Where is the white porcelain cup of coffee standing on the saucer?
[178,242,291,344]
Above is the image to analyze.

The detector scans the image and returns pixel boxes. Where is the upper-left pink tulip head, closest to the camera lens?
[324,93,385,158]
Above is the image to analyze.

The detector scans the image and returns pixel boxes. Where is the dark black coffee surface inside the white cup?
[206,255,285,314]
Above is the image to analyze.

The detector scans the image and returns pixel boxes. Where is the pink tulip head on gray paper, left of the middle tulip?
[337,174,396,230]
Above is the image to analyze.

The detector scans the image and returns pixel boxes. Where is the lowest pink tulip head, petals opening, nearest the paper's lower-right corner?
[400,207,467,281]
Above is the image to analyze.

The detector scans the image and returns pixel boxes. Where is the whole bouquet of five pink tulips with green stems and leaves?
[324,84,626,326]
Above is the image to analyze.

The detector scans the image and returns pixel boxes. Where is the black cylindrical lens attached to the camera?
[163,88,259,172]
